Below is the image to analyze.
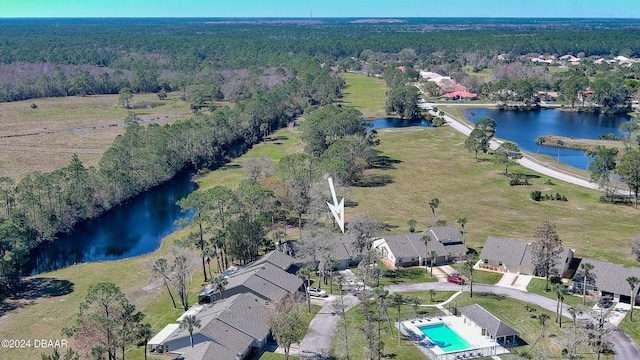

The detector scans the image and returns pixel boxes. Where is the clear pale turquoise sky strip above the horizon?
[0,0,640,18]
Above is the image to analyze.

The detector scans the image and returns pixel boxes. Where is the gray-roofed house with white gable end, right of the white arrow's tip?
[372,226,468,267]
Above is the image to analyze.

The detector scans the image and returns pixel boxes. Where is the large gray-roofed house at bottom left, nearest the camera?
[148,294,270,360]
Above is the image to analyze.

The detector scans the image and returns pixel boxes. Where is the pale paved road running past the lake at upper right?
[420,103,598,190]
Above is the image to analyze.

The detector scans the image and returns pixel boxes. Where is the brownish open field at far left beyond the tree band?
[0,93,191,181]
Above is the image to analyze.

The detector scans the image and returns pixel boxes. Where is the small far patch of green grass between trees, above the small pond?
[341,73,388,119]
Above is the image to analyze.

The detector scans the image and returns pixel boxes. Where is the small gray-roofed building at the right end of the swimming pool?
[460,304,520,347]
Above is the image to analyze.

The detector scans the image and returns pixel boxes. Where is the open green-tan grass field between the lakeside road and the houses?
[346,127,640,265]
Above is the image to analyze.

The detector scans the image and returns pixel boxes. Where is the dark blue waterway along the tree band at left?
[26,172,197,274]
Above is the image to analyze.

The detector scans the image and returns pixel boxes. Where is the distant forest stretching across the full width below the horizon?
[0,19,640,101]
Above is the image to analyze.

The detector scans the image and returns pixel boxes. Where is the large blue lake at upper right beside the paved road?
[464,108,631,170]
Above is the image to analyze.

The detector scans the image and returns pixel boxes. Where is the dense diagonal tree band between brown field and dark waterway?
[0,59,343,297]
